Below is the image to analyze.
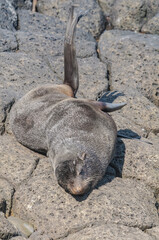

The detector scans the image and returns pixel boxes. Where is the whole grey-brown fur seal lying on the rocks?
[10,7,125,195]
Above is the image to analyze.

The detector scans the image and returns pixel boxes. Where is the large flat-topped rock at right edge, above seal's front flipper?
[99,30,159,106]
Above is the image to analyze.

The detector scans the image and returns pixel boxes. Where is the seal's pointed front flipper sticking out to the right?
[91,101,126,112]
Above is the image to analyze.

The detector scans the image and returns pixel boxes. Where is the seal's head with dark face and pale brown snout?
[55,154,102,195]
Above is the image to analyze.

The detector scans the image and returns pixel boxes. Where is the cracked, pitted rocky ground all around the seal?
[0,0,159,240]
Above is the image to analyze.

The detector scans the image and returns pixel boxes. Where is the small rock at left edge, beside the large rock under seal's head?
[0,178,15,216]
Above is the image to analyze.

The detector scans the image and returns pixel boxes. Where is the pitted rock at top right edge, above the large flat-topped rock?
[99,0,159,33]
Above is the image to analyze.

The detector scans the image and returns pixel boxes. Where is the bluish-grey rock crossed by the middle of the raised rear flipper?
[16,29,96,58]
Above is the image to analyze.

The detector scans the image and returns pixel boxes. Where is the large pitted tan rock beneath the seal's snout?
[13,160,159,238]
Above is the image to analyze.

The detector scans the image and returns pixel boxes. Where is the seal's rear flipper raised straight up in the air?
[64,7,86,96]
